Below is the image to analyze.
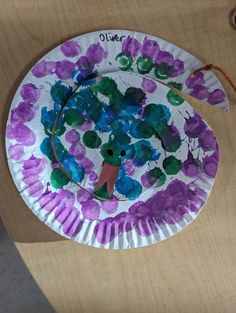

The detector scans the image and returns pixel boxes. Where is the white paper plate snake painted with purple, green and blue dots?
[6,30,221,249]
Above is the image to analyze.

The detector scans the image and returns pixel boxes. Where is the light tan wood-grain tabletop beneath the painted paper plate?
[0,0,236,313]
